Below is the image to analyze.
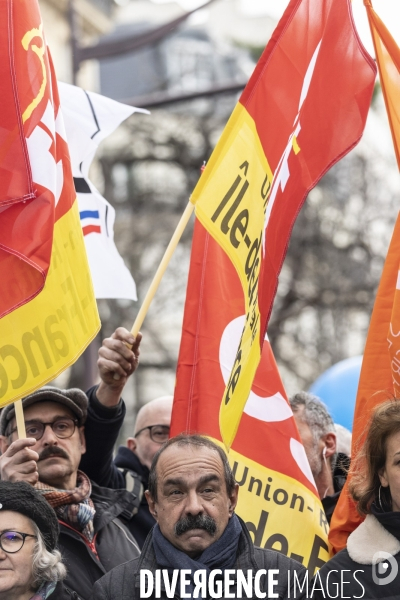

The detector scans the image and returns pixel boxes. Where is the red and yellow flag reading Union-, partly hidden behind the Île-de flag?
[171,221,329,573]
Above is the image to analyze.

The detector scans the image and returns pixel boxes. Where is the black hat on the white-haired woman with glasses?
[0,481,60,552]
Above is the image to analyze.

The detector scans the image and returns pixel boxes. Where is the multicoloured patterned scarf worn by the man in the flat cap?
[35,471,96,542]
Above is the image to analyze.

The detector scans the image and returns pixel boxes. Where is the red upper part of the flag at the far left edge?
[0,0,69,318]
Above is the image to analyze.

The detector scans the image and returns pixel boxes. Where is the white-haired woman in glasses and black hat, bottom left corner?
[0,481,80,600]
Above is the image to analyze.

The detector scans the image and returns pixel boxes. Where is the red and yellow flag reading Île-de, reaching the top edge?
[183,0,375,447]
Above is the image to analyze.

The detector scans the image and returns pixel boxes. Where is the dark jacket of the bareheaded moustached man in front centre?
[92,521,306,600]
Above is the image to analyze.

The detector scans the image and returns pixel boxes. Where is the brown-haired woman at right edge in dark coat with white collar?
[313,399,400,600]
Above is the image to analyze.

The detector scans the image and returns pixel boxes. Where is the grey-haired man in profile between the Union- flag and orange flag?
[289,392,350,523]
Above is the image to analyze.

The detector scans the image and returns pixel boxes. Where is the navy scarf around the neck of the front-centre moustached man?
[153,514,242,597]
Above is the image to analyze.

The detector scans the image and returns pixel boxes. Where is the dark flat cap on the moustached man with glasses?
[0,385,88,435]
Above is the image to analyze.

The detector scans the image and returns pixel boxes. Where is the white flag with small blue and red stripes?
[58,82,148,300]
